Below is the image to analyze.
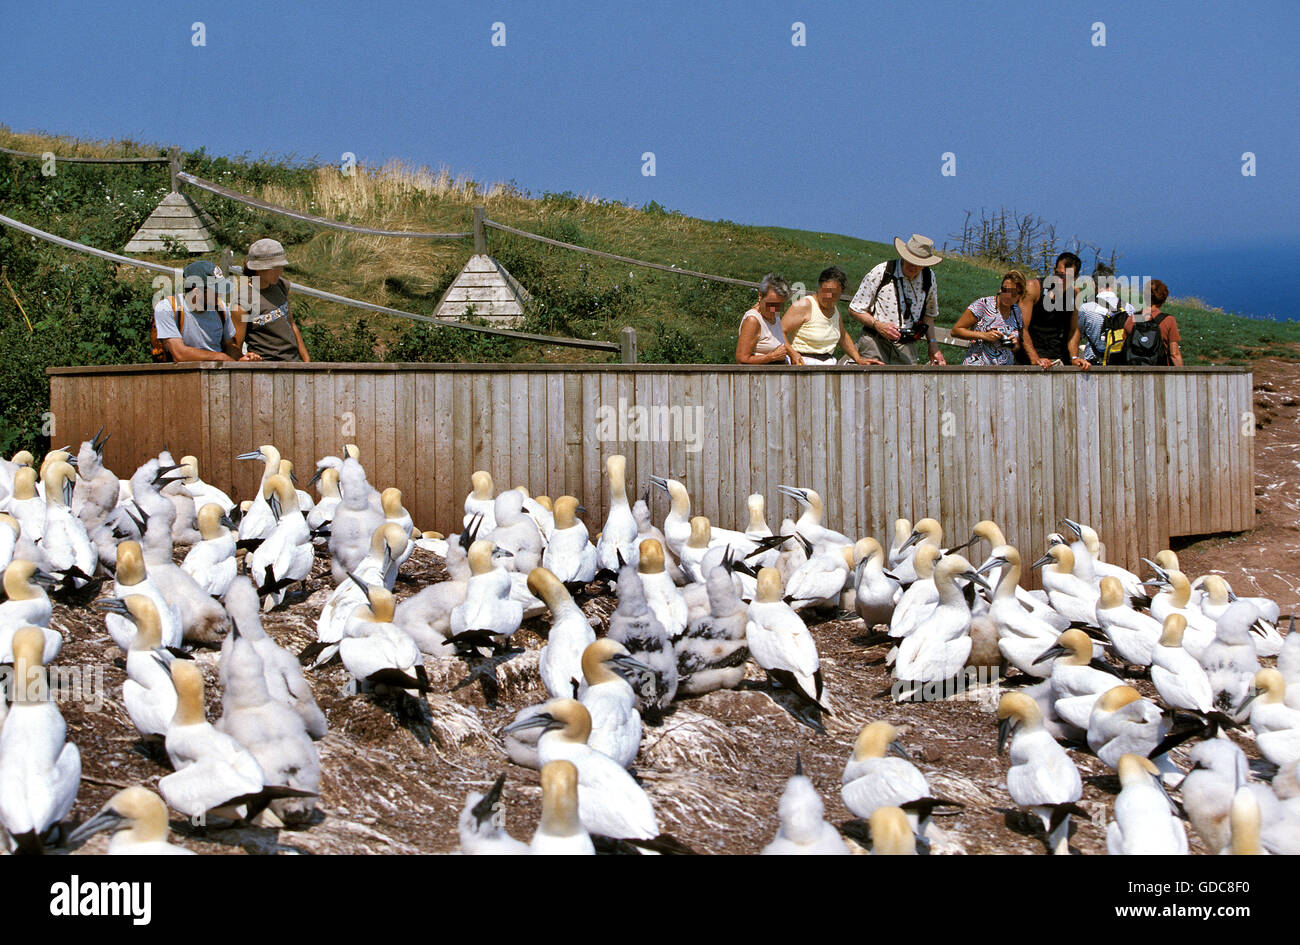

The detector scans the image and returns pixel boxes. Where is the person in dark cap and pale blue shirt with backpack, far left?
[152,259,261,361]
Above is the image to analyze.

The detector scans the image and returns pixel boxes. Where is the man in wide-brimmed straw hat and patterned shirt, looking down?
[849,233,946,364]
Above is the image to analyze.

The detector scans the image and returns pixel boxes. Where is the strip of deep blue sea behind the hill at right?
[1112,240,1300,321]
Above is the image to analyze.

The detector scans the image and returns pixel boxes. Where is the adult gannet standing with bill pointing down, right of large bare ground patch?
[997,693,1087,854]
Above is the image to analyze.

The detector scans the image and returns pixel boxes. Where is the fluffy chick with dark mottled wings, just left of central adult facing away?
[676,561,749,695]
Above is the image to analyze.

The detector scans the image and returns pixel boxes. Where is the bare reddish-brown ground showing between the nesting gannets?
[55,361,1300,854]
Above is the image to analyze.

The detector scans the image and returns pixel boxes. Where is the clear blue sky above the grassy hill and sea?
[0,0,1300,292]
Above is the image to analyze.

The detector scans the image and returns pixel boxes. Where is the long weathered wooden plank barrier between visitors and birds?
[49,363,1255,577]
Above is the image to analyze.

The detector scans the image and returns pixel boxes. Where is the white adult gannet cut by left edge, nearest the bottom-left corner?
[0,629,81,851]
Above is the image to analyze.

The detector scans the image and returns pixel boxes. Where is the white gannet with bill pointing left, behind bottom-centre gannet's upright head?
[506,699,659,840]
